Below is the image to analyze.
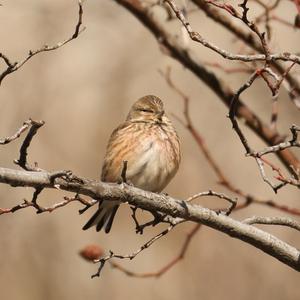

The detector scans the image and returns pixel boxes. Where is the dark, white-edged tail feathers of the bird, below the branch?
[82,200,120,233]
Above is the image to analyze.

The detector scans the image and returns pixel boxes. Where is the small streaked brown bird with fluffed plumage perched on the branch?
[83,95,180,233]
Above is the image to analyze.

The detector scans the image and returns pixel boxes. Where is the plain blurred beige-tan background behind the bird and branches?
[0,0,300,300]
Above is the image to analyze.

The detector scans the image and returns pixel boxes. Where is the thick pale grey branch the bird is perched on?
[0,168,300,271]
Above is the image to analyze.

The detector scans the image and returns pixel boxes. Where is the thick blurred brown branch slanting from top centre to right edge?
[115,0,300,174]
